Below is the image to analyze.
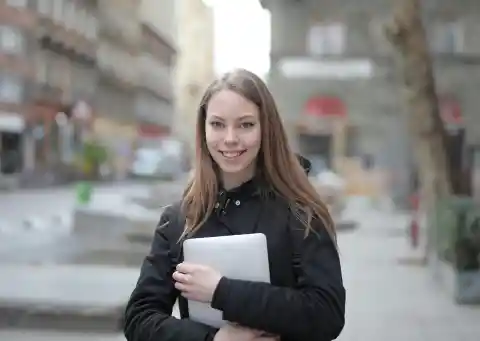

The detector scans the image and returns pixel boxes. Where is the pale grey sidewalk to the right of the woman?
[339,207,480,341]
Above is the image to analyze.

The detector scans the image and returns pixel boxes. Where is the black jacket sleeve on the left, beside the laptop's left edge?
[124,207,216,341]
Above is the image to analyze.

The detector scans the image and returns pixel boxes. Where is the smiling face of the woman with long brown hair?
[205,90,261,181]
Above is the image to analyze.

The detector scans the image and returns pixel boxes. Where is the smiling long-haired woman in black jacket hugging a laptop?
[125,70,345,341]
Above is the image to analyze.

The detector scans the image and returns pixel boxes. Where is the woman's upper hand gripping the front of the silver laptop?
[173,263,222,303]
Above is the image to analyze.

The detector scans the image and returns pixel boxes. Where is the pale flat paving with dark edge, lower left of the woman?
[0,265,138,334]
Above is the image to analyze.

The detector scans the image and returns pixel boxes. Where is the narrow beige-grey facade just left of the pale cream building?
[135,0,177,147]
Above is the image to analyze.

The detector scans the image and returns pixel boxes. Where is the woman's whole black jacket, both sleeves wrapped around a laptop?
[124,174,345,341]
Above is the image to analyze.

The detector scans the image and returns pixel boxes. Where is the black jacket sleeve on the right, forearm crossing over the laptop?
[211,217,345,341]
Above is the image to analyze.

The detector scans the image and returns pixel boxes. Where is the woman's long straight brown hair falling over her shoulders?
[182,69,336,241]
